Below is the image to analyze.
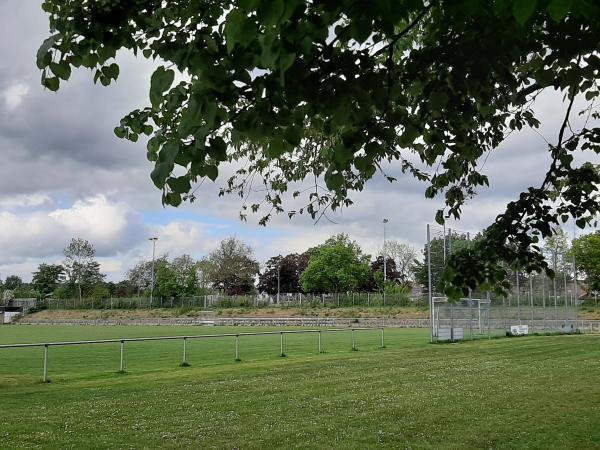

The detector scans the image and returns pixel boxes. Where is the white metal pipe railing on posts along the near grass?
[0,327,385,383]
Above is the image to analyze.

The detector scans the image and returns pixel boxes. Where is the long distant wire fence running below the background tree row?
[38,292,427,310]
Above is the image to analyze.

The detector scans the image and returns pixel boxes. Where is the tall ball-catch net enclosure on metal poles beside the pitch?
[425,225,578,342]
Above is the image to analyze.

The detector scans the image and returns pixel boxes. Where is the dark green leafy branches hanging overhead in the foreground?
[37,0,600,297]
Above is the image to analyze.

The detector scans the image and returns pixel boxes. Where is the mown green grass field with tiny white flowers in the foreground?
[0,326,600,449]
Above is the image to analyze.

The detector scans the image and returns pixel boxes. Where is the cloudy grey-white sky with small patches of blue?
[0,0,596,281]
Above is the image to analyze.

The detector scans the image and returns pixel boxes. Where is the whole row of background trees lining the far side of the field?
[5,232,600,300]
